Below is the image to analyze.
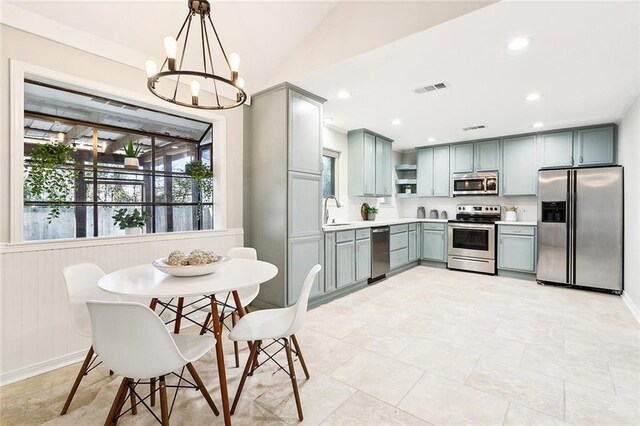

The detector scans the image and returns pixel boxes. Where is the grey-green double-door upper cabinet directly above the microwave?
[451,139,500,173]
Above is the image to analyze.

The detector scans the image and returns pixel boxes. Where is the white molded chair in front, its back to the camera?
[87,301,219,425]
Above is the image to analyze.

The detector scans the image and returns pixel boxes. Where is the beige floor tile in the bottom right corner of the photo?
[565,383,640,426]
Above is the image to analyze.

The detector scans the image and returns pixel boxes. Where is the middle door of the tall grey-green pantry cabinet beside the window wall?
[289,172,322,238]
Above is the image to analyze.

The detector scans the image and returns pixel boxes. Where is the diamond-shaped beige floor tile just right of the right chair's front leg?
[331,351,422,405]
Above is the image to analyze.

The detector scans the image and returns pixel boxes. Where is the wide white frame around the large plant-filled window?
[8,59,227,245]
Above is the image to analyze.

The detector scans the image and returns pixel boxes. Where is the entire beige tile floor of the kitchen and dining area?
[0,266,640,425]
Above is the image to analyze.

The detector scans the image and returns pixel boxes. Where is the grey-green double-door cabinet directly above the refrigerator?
[538,125,616,168]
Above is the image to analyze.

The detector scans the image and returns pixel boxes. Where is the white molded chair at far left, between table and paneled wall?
[60,263,120,415]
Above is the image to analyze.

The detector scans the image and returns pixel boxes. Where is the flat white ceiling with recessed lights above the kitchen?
[293,2,640,150]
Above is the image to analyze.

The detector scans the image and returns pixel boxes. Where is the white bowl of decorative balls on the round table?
[152,249,229,277]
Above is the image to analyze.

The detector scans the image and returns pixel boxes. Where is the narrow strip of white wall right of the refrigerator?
[618,95,640,321]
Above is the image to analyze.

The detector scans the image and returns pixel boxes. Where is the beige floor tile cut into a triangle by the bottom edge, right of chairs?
[322,391,427,426]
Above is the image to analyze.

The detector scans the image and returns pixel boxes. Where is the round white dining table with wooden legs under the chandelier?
[98,258,278,425]
